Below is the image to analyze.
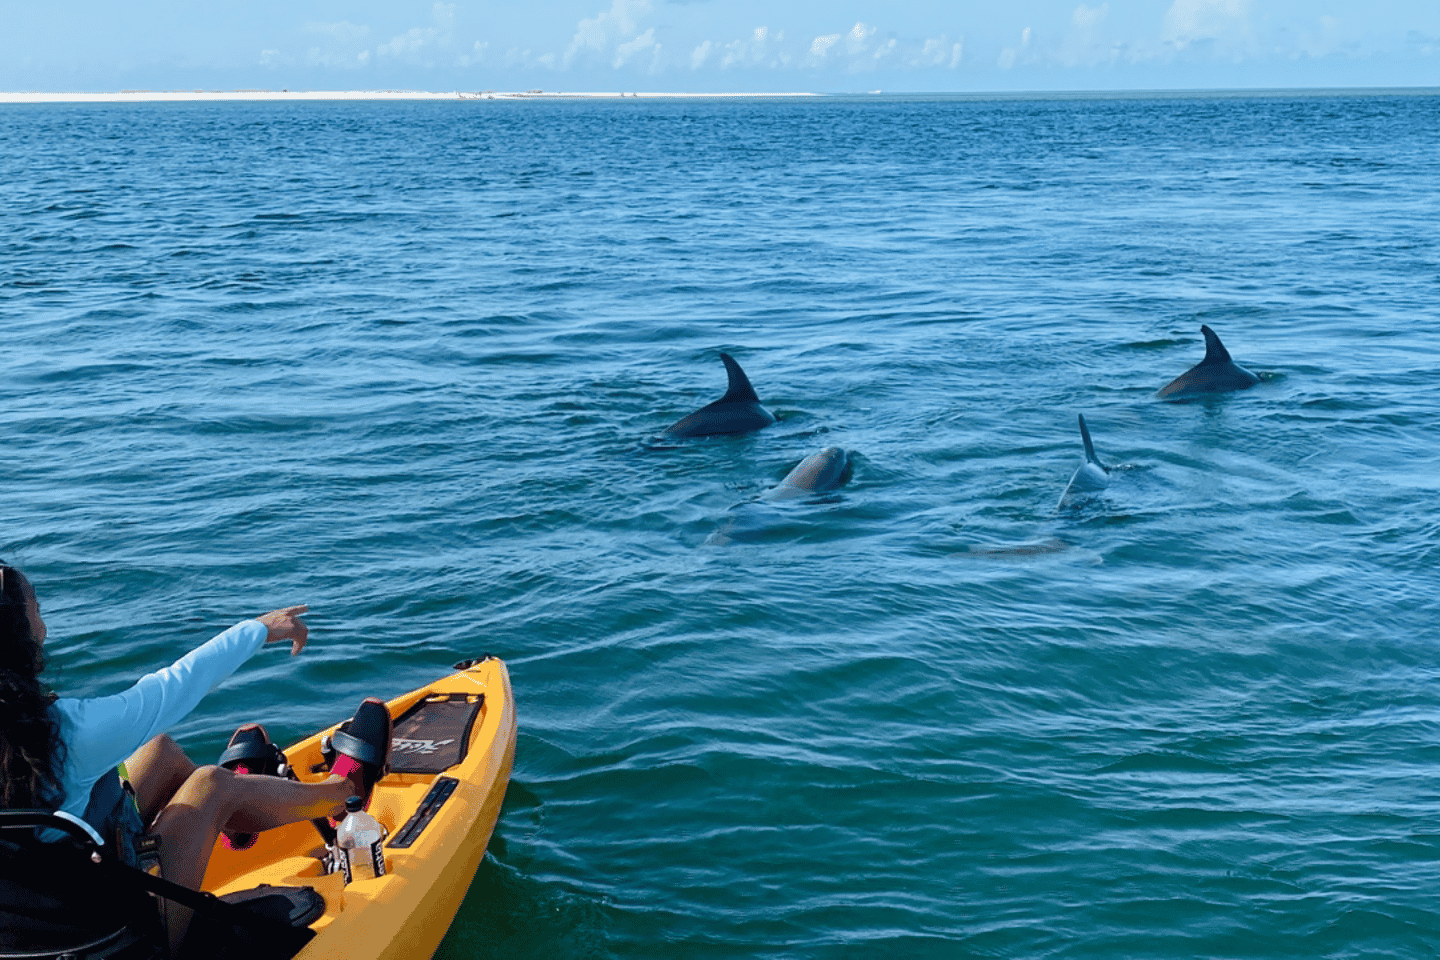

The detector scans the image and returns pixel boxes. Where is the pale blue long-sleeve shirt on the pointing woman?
[55,620,268,816]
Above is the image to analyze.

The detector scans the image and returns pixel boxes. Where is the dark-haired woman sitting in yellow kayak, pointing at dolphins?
[0,563,390,953]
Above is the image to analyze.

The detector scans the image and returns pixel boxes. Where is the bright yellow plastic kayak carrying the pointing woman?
[203,658,516,960]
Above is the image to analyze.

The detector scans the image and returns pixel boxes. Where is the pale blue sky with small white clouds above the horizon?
[0,0,1440,92]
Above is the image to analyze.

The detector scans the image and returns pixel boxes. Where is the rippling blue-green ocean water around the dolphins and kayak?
[0,92,1440,960]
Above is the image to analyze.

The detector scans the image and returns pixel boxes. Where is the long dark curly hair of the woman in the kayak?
[0,561,65,810]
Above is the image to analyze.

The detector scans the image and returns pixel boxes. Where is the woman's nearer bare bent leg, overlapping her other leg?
[147,765,356,956]
